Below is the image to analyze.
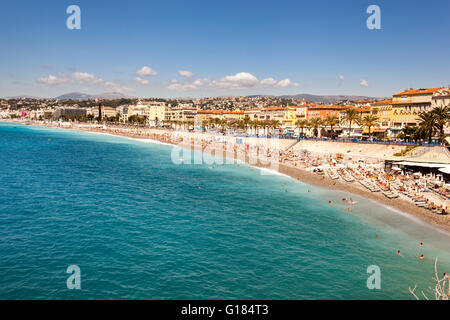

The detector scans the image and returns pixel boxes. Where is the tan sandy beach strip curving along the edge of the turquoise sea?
[9,121,450,232]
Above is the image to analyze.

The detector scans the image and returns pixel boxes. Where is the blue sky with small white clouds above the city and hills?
[0,0,450,97]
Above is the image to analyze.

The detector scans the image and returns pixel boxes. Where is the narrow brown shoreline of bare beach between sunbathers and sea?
[1,120,450,235]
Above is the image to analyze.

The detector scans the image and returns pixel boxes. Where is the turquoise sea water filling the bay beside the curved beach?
[0,123,450,299]
